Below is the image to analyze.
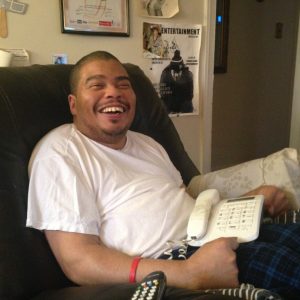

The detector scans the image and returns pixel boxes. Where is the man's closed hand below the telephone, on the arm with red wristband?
[183,238,239,289]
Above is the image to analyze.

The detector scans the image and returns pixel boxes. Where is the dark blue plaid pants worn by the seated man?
[159,224,300,300]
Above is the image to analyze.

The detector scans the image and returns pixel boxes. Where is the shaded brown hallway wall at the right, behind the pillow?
[212,0,299,170]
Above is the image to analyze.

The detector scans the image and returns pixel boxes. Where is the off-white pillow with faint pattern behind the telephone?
[187,148,300,209]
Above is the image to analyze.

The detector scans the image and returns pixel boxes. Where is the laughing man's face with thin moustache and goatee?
[69,59,136,149]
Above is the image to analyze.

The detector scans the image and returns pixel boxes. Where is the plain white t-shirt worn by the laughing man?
[27,124,194,257]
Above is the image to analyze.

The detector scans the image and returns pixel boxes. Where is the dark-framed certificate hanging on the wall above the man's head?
[60,0,129,36]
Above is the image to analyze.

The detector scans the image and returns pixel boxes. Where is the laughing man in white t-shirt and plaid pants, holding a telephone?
[27,51,300,298]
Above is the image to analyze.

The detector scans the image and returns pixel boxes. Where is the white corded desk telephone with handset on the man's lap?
[187,189,264,246]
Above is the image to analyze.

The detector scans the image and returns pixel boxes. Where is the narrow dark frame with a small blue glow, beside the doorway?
[214,0,230,73]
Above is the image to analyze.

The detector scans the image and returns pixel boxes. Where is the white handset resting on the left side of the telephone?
[187,189,220,240]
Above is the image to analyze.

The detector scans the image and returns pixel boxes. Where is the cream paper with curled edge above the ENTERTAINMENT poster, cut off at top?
[139,0,179,18]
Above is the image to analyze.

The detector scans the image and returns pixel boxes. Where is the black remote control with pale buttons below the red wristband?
[131,271,166,300]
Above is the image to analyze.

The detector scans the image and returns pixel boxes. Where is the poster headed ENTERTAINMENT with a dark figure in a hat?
[143,22,202,116]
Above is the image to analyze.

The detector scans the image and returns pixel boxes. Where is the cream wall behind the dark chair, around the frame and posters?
[0,0,215,171]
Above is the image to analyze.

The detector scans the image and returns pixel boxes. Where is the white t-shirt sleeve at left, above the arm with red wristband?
[26,156,100,235]
